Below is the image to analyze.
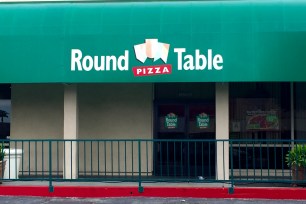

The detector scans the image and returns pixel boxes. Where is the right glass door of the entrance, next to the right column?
[186,103,216,178]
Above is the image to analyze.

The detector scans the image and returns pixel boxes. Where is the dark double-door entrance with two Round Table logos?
[154,101,216,179]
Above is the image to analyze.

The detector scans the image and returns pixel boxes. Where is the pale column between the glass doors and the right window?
[216,83,229,180]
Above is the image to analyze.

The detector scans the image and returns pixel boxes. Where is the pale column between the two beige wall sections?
[63,84,78,179]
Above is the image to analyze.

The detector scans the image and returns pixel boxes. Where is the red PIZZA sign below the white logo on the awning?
[133,64,172,76]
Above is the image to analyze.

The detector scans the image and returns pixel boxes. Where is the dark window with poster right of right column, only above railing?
[229,82,291,140]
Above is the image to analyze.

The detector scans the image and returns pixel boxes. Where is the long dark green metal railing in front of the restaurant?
[0,139,306,192]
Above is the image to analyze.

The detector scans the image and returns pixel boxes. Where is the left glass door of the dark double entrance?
[154,104,186,176]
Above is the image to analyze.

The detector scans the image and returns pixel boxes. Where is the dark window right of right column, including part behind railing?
[229,82,291,171]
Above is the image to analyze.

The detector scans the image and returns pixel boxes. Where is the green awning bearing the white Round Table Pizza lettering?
[0,0,306,83]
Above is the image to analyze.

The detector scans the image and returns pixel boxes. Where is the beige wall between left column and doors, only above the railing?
[78,84,153,139]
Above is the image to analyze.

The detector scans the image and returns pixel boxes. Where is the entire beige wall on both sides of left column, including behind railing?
[11,84,153,174]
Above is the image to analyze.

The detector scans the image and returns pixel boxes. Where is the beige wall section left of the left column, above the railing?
[11,84,64,139]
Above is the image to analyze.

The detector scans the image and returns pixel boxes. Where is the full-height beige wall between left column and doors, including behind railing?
[78,84,153,173]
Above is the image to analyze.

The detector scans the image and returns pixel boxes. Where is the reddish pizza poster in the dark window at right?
[246,110,279,130]
